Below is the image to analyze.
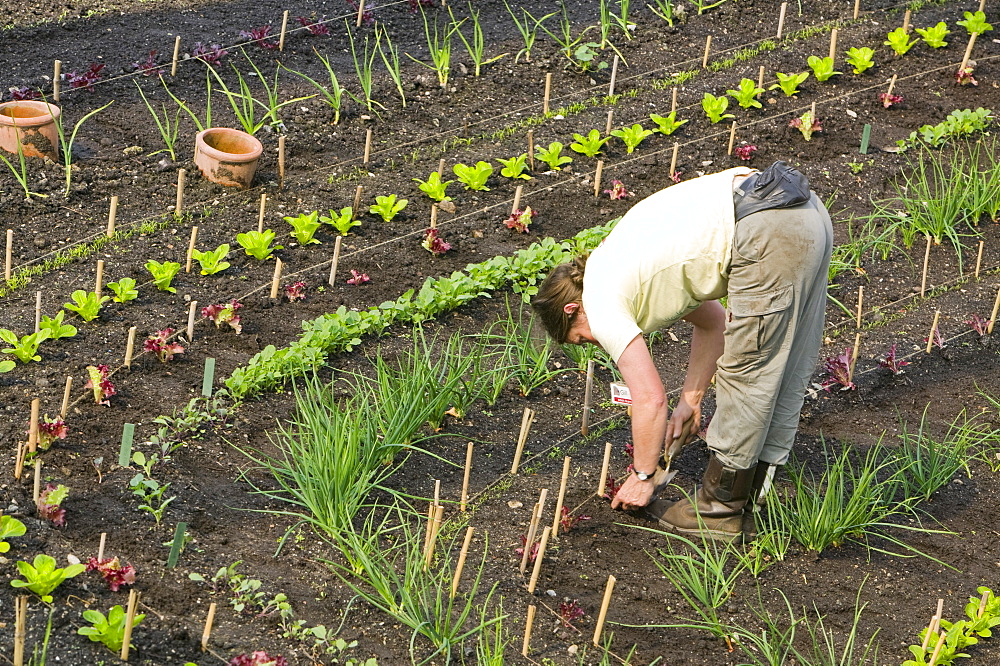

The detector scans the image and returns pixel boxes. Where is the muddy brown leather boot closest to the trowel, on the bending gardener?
[647,453,756,541]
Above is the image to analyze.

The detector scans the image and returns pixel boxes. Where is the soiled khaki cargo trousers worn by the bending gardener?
[707,193,833,469]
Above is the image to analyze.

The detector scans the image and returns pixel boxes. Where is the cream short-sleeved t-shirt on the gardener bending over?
[583,167,753,362]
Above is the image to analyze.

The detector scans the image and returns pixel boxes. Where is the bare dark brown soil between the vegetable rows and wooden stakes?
[0,0,1000,665]
